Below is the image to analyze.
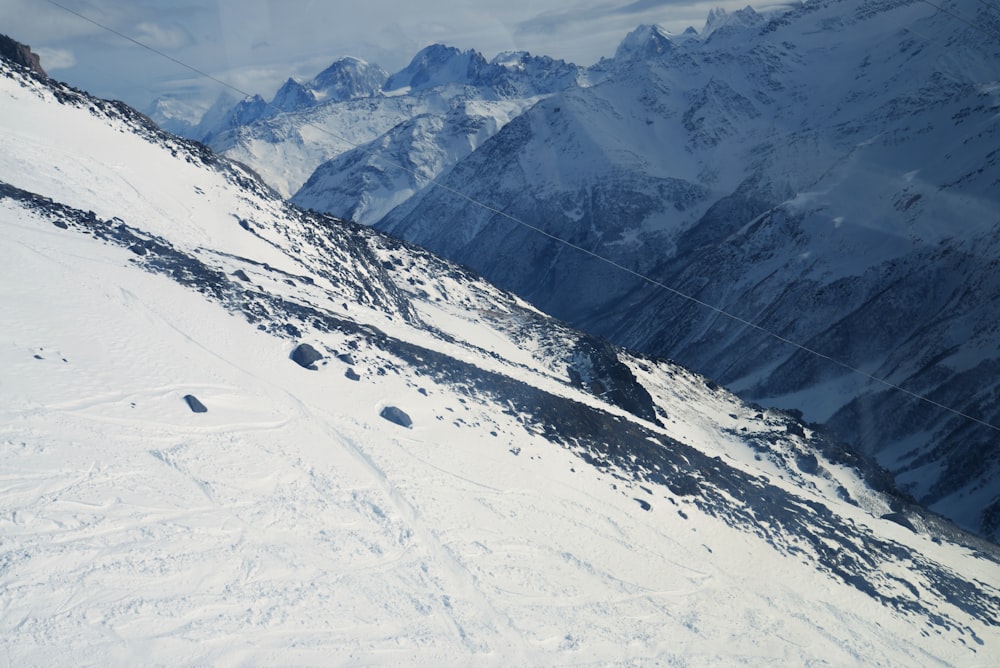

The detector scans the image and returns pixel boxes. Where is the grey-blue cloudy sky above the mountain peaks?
[0,0,746,115]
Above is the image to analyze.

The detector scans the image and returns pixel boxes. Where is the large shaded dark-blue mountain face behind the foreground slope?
[377,0,1000,540]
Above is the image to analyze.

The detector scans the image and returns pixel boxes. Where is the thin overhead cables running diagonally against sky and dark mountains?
[47,0,1000,432]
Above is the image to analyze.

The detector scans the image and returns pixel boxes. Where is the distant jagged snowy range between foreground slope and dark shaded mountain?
[181,44,587,204]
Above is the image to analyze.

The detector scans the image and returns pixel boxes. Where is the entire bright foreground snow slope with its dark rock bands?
[0,45,1000,665]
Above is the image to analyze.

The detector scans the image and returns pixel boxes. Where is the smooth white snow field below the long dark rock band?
[0,208,995,665]
